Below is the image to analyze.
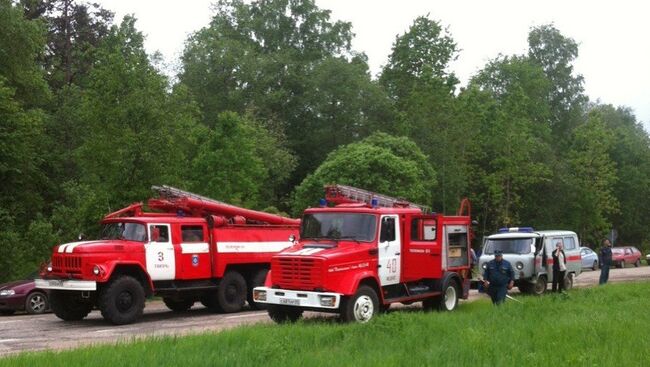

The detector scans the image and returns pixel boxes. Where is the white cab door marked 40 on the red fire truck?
[378,215,402,286]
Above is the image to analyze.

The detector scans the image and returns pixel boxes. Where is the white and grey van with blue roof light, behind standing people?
[479,227,582,294]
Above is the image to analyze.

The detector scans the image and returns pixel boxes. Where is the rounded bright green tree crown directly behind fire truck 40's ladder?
[293,133,435,215]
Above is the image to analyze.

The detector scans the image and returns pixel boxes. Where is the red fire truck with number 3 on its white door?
[36,186,300,324]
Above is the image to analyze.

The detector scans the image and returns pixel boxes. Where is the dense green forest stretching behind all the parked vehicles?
[0,0,650,281]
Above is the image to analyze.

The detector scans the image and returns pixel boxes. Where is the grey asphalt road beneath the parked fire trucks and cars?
[0,266,650,357]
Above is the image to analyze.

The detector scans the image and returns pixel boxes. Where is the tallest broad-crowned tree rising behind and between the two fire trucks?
[179,0,394,193]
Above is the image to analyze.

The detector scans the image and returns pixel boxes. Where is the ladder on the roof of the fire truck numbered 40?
[325,184,430,213]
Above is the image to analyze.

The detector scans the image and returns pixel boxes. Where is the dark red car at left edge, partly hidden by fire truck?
[0,273,50,315]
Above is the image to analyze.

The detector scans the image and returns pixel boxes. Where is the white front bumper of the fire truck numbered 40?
[253,287,341,310]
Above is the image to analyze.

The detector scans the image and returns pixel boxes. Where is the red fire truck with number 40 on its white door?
[253,185,471,322]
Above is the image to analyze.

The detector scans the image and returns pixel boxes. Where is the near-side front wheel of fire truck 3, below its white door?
[99,275,145,325]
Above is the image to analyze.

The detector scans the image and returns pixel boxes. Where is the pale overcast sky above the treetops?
[98,0,650,131]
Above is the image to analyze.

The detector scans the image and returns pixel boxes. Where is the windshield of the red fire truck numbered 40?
[300,213,377,242]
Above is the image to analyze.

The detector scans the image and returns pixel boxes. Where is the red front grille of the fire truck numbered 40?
[271,257,323,290]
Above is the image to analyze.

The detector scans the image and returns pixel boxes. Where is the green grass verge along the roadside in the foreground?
[0,282,650,367]
